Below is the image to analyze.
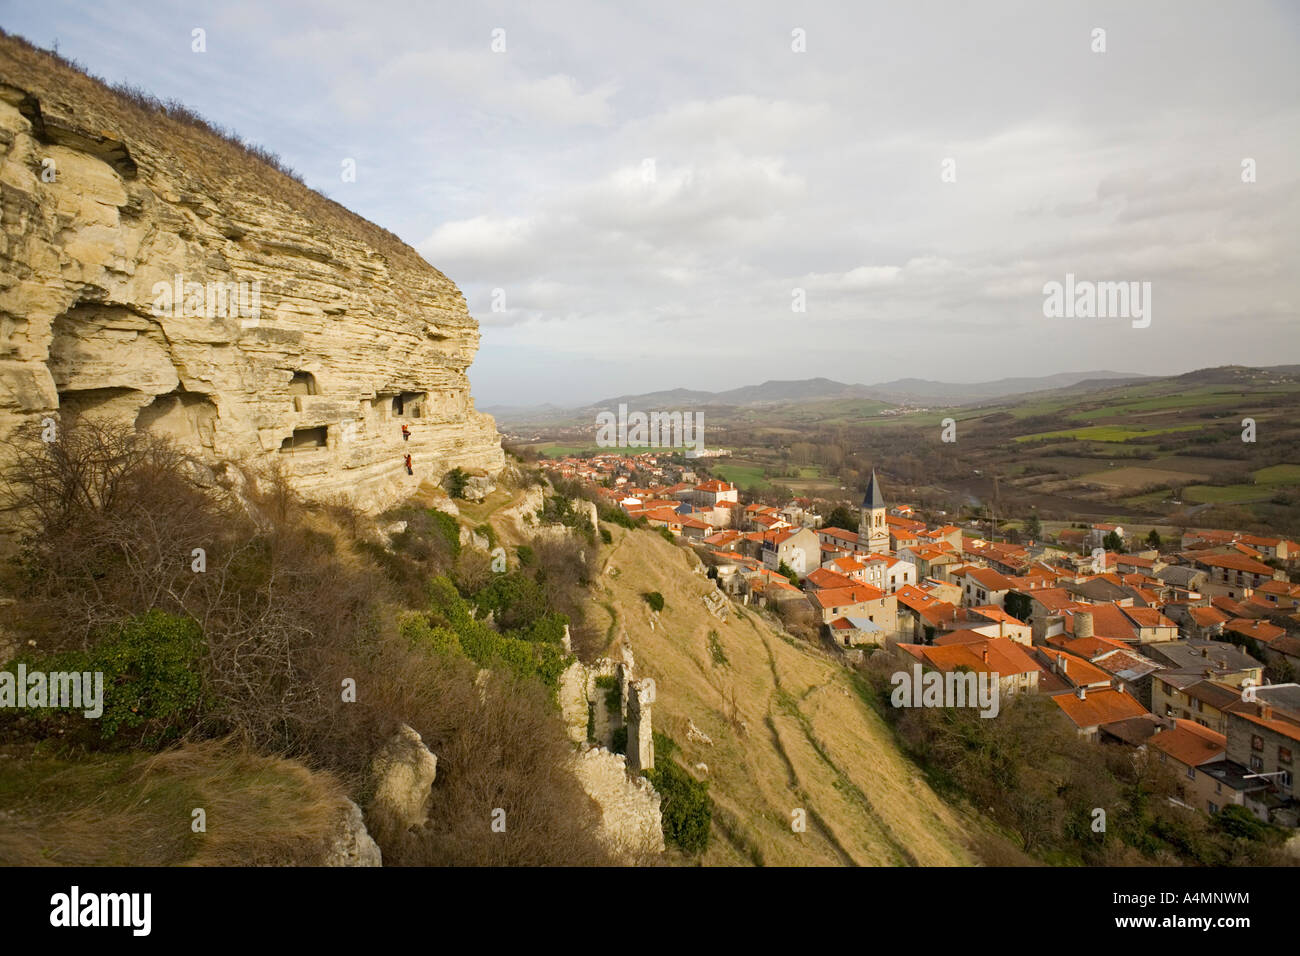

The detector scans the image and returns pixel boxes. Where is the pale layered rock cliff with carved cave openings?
[0,36,504,510]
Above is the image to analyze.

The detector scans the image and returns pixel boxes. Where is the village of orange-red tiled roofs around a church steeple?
[541,453,1300,827]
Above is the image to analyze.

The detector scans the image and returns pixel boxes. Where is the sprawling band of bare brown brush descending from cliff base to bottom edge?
[5,420,608,865]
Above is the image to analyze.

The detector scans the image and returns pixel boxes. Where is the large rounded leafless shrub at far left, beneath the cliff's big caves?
[0,419,241,649]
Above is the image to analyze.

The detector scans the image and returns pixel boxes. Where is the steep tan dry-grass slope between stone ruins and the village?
[593,525,976,866]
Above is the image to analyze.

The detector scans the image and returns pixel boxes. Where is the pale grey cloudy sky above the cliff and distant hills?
[0,0,1300,407]
